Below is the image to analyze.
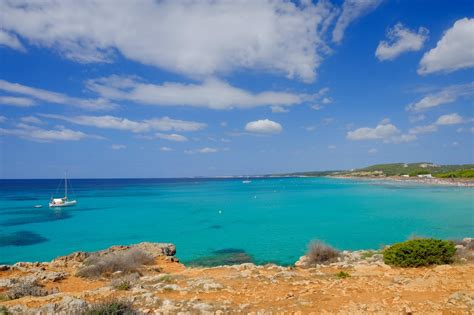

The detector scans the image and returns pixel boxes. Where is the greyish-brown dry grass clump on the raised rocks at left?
[77,248,154,278]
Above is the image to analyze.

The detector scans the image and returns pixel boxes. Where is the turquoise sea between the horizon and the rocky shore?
[0,178,474,264]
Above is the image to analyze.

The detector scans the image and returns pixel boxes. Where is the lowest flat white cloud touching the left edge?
[0,124,97,142]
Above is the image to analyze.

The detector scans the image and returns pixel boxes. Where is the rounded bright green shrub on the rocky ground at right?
[383,238,456,267]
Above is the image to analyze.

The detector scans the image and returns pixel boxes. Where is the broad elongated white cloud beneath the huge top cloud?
[87,76,308,109]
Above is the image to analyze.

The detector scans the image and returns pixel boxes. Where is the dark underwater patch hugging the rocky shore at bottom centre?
[187,248,253,267]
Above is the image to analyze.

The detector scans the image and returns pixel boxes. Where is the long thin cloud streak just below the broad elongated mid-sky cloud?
[39,114,206,132]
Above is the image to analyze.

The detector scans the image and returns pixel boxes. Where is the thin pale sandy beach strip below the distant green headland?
[325,175,474,187]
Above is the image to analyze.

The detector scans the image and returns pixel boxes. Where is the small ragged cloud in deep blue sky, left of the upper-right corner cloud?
[375,23,429,61]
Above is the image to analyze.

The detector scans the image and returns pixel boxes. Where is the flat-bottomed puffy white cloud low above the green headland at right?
[346,121,416,143]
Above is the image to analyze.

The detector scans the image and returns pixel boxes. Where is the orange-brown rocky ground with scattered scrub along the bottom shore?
[0,239,474,314]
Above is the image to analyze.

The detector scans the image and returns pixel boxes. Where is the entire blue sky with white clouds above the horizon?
[0,0,474,178]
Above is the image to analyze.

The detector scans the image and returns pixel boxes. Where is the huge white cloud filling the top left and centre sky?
[1,0,340,81]
